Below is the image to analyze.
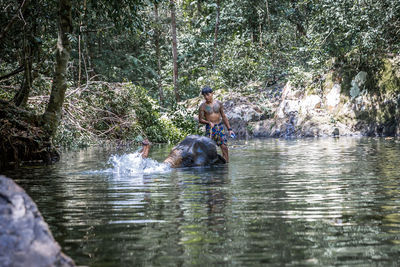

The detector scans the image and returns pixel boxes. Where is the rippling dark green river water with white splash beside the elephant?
[5,138,400,266]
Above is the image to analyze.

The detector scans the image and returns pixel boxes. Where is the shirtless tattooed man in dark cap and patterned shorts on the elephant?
[199,87,234,162]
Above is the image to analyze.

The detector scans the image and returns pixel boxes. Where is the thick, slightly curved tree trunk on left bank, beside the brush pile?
[43,0,72,138]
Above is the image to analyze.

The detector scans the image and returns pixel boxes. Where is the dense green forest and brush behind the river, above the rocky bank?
[0,0,400,151]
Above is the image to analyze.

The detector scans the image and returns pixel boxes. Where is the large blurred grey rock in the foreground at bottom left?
[0,176,75,267]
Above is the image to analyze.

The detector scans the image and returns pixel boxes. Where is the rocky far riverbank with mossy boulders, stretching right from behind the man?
[185,57,400,138]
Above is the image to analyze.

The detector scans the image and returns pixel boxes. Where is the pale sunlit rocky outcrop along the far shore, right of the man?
[225,57,400,137]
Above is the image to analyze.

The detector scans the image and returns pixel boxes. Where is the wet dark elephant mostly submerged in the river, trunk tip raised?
[142,135,226,168]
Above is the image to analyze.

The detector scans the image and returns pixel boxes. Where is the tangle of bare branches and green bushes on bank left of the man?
[50,83,198,147]
